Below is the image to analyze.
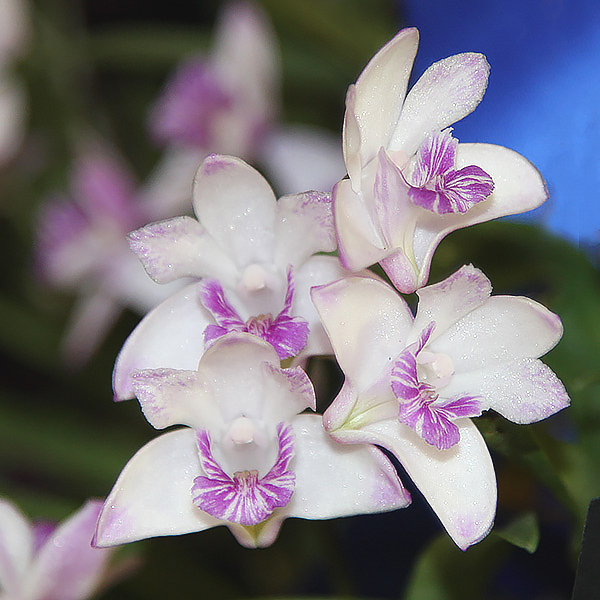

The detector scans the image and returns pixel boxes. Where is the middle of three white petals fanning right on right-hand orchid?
[426,288,563,372]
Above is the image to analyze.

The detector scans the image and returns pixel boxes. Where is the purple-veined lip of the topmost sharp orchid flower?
[408,128,494,215]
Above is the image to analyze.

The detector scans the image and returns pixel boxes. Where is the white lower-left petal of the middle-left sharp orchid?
[113,284,214,400]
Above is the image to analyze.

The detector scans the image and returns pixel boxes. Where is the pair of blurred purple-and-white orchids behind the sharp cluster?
[36,0,344,364]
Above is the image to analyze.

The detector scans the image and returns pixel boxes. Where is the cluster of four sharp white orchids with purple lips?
[95,29,569,549]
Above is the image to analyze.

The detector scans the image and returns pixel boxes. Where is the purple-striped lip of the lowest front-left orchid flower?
[192,423,295,525]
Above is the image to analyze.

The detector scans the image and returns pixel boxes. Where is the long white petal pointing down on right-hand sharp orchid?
[348,419,496,550]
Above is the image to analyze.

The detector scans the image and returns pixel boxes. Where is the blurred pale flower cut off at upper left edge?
[0,0,31,163]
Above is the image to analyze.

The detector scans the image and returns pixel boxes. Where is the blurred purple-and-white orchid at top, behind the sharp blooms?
[144,1,344,219]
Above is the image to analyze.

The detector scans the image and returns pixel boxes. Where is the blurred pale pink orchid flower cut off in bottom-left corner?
[0,500,117,600]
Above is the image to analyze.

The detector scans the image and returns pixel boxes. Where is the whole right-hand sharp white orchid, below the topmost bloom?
[313,266,569,549]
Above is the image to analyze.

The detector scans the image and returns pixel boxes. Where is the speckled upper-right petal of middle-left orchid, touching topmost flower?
[275,192,337,269]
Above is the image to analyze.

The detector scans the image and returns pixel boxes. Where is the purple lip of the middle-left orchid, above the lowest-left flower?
[198,266,309,360]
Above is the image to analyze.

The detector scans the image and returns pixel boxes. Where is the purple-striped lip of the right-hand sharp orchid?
[391,321,482,450]
